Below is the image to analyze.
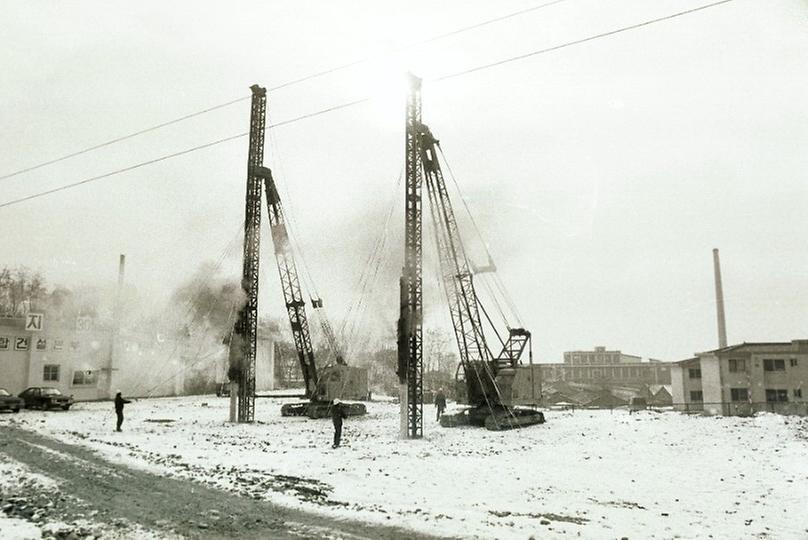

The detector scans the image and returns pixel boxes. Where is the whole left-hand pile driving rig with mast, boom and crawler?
[229,85,367,422]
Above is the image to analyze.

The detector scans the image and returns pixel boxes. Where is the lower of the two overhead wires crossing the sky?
[0,0,734,208]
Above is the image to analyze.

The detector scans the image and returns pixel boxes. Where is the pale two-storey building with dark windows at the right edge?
[671,339,808,415]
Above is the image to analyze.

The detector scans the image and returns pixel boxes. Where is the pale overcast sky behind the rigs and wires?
[0,0,808,361]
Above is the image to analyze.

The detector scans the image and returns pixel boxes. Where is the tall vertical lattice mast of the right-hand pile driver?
[398,74,424,439]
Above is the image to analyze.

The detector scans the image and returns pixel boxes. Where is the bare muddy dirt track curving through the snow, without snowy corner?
[0,425,442,539]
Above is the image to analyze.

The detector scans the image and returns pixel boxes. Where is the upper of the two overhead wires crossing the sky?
[0,0,567,184]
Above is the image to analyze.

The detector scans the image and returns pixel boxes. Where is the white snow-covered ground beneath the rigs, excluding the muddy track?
[0,396,808,539]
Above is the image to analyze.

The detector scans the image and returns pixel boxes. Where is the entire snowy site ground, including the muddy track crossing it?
[0,396,808,539]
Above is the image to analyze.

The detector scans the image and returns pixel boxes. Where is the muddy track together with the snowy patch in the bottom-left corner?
[0,425,436,539]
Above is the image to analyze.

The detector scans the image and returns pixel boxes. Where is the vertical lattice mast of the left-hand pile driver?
[230,85,267,422]
